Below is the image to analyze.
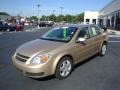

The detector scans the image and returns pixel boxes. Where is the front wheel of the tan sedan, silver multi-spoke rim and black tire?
[55,57,73,79]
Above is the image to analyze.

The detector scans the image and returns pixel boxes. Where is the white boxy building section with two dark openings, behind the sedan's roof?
[84,11,99,24]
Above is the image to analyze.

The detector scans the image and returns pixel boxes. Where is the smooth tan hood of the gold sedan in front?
[16,39,65,57]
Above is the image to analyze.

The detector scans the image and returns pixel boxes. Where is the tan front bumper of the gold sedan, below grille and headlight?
[12,56,53,78]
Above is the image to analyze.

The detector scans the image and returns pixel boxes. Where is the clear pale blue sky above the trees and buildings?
[0,0,112,16]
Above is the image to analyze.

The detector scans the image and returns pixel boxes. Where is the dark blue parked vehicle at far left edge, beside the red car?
[0,21,16,31]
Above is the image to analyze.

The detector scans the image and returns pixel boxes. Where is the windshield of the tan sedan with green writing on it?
[41,27,77,42]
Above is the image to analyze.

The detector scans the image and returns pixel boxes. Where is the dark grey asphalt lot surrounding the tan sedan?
[0,28,120,90]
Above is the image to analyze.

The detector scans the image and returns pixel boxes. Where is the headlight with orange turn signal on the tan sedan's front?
[30,55,50,65]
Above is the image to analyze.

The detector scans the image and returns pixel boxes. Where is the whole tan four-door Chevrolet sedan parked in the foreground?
[12,25,108,79]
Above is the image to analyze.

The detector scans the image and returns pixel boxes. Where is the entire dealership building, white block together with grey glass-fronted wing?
[84,0,120,30]
